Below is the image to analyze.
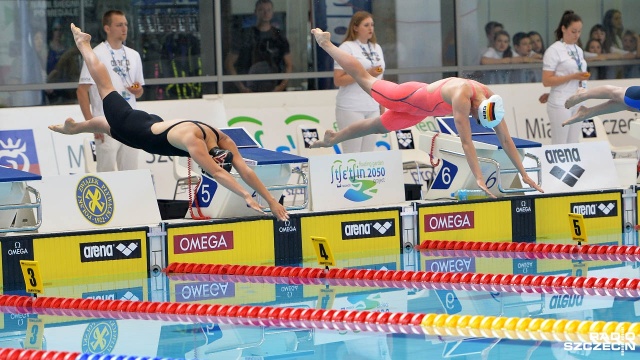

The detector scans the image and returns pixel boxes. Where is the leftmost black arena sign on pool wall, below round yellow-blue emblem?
[80,240,142,262]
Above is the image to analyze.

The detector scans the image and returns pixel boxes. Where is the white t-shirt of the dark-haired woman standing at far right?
[542,41,587,106]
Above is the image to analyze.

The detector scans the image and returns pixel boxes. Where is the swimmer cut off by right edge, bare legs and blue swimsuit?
[562,85,640,126]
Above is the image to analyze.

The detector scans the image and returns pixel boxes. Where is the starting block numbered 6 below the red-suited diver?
[418,117,542,200]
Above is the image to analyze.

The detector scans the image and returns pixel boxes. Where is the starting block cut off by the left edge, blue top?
[0,166,42,235]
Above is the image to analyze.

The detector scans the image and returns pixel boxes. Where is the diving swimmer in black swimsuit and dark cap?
[49,24,289,221]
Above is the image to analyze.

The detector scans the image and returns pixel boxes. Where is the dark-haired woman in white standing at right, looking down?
[542,10,590,144]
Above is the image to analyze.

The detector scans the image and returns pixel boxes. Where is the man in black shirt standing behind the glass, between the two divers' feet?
[225,0,293,93]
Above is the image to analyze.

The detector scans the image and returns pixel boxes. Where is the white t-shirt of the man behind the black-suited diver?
[78,42,144,116]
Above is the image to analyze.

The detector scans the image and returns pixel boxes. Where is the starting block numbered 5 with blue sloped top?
[186,127,309,218]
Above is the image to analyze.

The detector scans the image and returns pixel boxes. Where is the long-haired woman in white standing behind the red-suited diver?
[333,11,385,153]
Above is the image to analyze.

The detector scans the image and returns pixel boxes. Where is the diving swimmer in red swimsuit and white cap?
[311,29,543,197]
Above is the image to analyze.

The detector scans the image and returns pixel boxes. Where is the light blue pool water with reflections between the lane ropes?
[0,248,640,360]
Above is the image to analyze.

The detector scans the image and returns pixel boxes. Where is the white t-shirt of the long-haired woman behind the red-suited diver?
[333,40,385,111]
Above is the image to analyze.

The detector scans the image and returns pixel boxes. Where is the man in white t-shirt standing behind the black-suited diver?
[76,10,144,172]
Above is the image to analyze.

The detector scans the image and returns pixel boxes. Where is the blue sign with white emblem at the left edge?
[0,130,40,174]
